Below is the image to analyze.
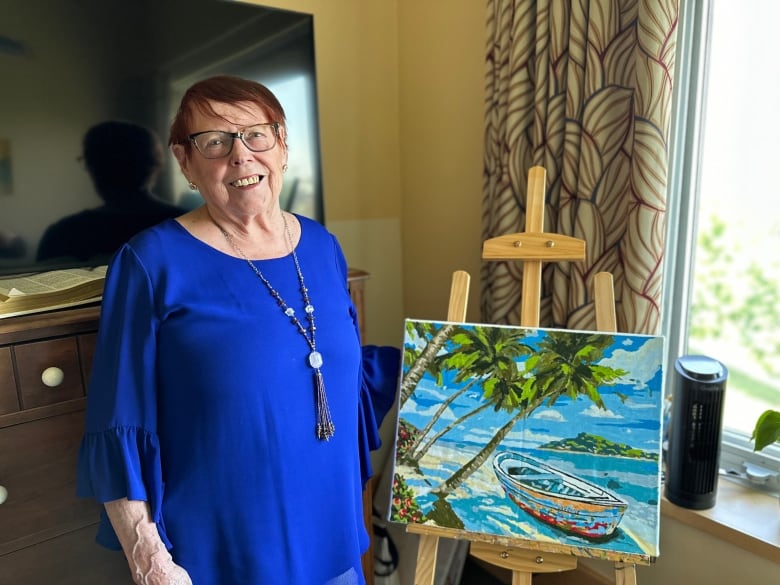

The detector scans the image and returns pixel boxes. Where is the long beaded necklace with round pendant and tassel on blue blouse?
[211,212,336,441]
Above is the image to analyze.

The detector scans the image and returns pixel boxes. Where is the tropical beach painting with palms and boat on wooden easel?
[389,320,664,559]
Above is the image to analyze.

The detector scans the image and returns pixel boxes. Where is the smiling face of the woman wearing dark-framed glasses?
[173,102,287,217]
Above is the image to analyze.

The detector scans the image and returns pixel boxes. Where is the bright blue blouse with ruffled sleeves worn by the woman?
[78,217,400,585]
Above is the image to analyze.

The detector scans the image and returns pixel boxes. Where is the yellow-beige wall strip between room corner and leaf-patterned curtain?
[399,0,486,321]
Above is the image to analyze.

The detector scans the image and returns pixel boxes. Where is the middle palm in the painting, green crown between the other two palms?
[406,325,534,465]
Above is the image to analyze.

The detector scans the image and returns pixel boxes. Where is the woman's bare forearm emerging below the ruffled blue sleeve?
[105,498,192,585]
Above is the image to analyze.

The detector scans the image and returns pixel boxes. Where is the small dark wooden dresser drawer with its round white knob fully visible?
[13,337,84,409]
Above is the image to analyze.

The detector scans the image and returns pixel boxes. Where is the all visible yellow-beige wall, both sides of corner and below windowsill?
[248,0,780,585]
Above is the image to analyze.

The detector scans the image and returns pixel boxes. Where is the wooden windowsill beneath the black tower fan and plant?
[661,477,780,564]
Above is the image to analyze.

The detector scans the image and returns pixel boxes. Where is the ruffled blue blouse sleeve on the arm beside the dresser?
[76,246,170,549]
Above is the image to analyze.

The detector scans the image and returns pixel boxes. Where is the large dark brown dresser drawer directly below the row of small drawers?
[0,410,100,558]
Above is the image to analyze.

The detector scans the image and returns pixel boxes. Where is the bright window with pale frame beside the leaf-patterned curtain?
[664,0,780,489]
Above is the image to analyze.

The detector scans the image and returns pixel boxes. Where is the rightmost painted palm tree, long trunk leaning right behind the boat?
[436,331,627,497]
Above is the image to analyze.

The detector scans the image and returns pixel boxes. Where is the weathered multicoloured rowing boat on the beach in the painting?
[493,451,628,539]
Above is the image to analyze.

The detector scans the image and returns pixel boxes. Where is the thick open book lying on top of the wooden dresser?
[0,266,107,318]
